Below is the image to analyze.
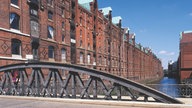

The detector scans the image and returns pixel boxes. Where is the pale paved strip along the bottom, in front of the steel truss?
[0,96,192,108]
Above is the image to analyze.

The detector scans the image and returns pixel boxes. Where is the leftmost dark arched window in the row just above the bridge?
[11,39,21,55]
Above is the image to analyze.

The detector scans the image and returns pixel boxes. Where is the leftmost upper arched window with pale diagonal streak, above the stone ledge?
[10,13,20,30]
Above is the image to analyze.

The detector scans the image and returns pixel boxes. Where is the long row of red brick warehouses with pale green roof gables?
[0,0,162,80]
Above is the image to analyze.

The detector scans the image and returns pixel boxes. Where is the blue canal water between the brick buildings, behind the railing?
[149,77,179,97]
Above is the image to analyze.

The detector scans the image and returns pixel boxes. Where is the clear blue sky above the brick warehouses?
[98,0,192,69]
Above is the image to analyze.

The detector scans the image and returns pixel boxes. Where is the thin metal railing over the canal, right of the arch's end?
[147,84,192,98]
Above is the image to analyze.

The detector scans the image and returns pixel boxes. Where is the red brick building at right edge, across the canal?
[179,31,192,81]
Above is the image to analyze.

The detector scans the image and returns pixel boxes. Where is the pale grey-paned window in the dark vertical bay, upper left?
[31,20,39,38]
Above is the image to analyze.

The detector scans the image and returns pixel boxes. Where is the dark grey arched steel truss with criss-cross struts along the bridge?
[0,62,182,104]
